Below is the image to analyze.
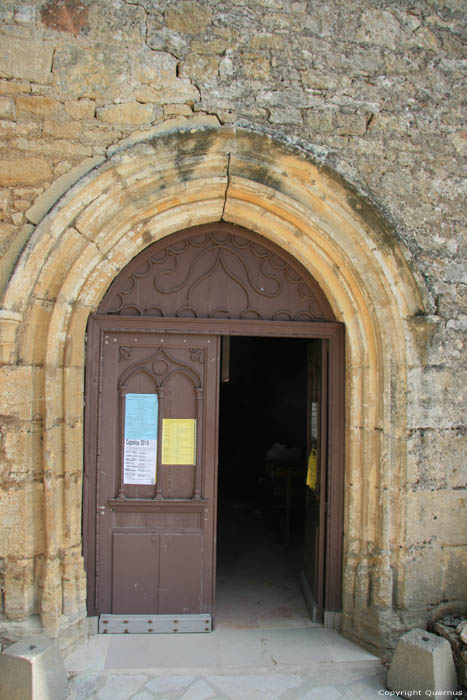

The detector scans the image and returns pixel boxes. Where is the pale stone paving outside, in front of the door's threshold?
[66,627,386,700]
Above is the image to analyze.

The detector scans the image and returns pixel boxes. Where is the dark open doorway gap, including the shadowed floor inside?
[216,336,321,628]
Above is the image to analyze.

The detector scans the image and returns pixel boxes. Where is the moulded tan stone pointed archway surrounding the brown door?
[3,128,423,647]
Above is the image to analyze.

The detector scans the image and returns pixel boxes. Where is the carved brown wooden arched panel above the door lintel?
[98,223,335,321]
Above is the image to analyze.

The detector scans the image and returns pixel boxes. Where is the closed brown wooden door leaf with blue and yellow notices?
[86,317,219,615]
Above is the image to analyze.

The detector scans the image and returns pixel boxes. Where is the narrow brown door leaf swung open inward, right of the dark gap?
[302,340,328,622]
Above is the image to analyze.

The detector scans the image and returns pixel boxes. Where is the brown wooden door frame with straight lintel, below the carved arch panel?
[83,314,345,624]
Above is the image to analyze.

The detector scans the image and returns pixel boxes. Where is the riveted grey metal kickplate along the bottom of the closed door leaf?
[99,613,212,634]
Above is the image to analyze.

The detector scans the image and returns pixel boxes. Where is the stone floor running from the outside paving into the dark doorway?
[65,509,387,700]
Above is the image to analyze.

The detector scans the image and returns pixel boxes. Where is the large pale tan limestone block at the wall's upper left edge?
[0,36,54,83]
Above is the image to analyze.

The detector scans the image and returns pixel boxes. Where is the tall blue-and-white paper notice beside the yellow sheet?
[123,394,158,485]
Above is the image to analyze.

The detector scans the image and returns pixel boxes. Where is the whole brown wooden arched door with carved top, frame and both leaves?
[84,223,344,632]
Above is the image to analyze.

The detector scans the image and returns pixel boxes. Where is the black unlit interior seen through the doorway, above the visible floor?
[217,337,310,580]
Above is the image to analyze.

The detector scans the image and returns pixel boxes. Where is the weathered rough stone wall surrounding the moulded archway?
[0,0,467,650]
